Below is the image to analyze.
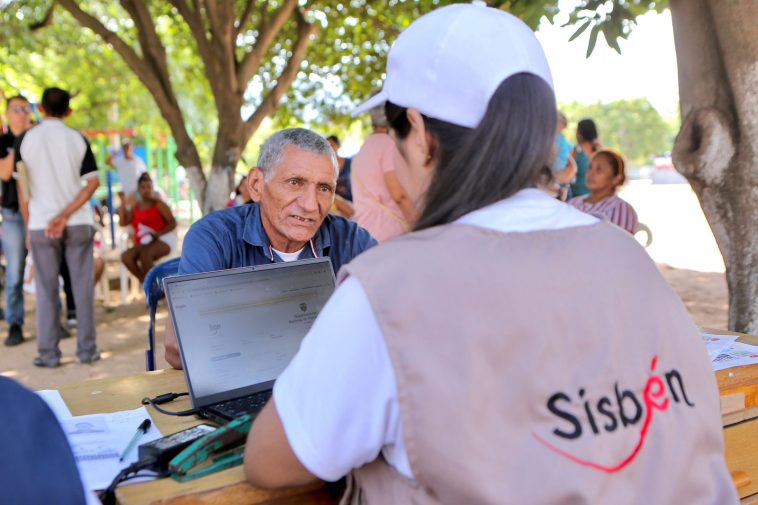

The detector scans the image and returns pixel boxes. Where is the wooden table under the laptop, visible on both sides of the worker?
[60,330,758,505]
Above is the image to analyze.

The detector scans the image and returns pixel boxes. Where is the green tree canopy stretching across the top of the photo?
[0,0,666,168]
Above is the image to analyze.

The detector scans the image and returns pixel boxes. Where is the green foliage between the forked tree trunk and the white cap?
[274,0,558,127]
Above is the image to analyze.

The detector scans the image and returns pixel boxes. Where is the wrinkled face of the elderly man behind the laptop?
[248,146,337,252]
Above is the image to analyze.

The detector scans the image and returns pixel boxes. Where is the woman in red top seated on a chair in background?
[118,173,177,282]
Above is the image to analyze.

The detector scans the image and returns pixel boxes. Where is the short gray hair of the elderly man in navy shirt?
[258,128,339,182]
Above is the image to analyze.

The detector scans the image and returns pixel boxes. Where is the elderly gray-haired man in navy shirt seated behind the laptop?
[165,128,376,368]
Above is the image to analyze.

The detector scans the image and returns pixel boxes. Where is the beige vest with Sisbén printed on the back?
[340,223,737,505]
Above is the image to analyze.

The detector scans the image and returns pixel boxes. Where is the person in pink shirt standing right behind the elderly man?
[352,107,416,242]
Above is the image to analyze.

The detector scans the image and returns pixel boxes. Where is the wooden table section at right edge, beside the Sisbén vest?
[716,330,758,504]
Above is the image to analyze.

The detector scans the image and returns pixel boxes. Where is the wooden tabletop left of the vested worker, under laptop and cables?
[60,370,336,505]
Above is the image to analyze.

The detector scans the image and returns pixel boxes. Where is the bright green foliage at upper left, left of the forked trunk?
[0,0,218,157]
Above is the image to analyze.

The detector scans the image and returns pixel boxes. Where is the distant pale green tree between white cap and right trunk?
[559,98,679,165]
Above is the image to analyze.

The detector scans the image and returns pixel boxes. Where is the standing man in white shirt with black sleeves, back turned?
[15,88,100,367]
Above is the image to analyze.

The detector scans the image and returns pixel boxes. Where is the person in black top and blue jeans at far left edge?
[0,95,32,346]
